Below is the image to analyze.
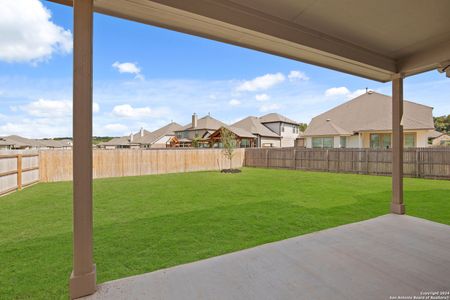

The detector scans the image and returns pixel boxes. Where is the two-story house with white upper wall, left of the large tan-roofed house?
[259,113,300,147]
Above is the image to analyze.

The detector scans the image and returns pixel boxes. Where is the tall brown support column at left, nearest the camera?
[70,0,96,299]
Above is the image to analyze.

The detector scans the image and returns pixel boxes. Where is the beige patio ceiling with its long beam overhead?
[51,0,450,82]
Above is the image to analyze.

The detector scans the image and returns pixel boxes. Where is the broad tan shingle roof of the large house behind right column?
[305,92,434,136]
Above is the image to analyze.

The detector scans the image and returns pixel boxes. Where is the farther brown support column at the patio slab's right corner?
[391,74,405,215]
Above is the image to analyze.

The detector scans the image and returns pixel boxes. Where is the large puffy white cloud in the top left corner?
[0,0,72,63]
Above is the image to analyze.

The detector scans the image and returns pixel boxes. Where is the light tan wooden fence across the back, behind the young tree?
[39,149,245,182]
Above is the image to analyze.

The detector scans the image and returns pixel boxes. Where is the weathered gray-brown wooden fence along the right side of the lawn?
[244,148,450,179]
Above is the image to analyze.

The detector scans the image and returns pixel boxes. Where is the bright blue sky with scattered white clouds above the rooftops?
[0,0,450,137]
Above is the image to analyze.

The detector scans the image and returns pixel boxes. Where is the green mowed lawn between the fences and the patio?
[0,168,450,299]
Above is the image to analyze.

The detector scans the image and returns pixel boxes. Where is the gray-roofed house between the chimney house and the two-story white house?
[231,116,281,147]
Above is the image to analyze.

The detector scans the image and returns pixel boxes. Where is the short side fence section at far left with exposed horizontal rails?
[0,151,39,195]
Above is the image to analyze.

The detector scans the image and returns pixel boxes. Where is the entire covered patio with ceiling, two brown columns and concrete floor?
[43,0,450,299]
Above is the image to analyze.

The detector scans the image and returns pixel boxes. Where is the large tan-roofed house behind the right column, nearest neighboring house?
[302,91,434,148]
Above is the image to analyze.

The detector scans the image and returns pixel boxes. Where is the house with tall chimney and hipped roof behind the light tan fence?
[175,113,227,147]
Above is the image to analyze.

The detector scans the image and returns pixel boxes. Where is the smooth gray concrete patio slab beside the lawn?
[83,214,450,300]
